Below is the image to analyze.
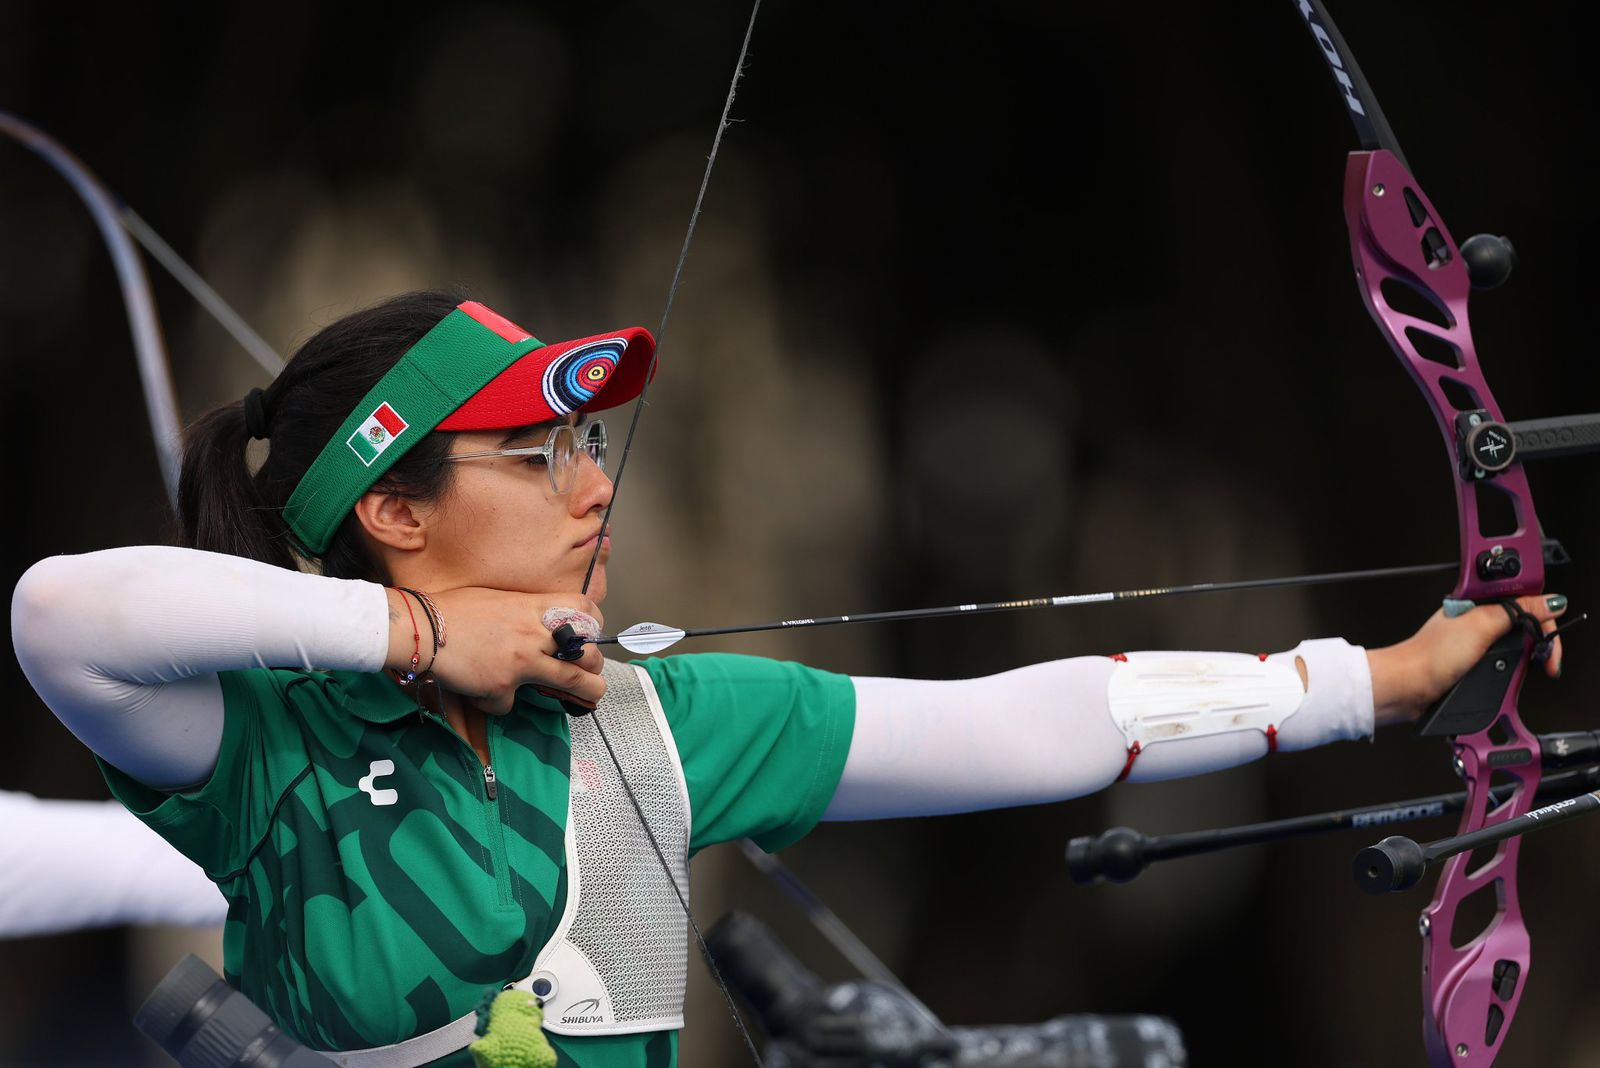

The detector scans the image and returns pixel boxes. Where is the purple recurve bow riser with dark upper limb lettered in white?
[1296,0,1544,1066]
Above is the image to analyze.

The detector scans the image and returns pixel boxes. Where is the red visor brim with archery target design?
[438,319,656,430]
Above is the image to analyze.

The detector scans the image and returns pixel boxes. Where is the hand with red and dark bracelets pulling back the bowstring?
[386,587,605,716]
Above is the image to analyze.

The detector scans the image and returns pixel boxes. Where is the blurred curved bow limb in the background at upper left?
[0,112,181,512]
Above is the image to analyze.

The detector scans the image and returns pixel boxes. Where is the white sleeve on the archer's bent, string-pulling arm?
[11,545,389,790]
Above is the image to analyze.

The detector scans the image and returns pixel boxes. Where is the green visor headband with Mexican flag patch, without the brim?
[283,307,544,553]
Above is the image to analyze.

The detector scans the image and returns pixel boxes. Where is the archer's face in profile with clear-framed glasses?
[426,424,611,601]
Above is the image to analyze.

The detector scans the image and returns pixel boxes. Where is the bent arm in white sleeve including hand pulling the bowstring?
[11,545,605,790]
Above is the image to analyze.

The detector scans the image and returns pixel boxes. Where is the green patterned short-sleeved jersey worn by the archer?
[102,654,854,1068]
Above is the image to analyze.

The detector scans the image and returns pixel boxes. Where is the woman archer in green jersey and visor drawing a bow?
[11,293,1565,1068]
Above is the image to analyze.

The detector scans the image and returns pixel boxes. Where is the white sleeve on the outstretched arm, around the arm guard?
[822,638,1373,820]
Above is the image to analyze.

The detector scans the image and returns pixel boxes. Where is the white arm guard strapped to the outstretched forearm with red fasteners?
[1106,652,1306,757]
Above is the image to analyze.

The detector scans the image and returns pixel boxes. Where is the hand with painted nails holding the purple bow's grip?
[1366,593,1566,726]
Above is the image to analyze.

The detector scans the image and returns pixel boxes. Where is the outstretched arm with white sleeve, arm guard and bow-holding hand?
[822,598,1565,820]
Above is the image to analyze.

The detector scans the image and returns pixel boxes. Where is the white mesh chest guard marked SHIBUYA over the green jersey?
[531,660,690,1034]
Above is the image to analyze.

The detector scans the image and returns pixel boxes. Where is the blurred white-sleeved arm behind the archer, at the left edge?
[0,790,227,938]
